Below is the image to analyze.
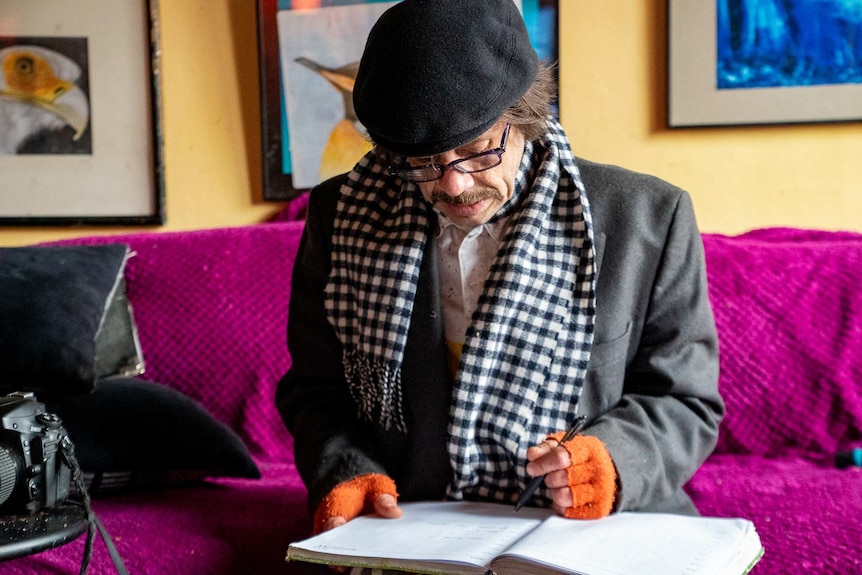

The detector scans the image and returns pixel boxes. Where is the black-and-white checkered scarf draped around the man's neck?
[326,119,595,502]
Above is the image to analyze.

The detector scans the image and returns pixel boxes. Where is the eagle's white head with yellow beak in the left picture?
[0,44,92,155]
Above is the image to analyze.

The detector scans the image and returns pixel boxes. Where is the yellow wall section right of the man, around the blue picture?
[560,0,862,233]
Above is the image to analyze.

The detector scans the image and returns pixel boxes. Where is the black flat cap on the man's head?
[353,0,538,156]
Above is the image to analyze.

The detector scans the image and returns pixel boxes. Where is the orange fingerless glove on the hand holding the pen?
[548,431,617,519]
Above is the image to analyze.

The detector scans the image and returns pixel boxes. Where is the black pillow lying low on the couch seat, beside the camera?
[44,378,260,495]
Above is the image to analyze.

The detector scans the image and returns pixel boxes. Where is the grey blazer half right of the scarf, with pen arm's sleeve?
[582,164,724,511]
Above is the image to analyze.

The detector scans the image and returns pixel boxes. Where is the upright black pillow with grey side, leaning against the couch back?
[0,244,143,398]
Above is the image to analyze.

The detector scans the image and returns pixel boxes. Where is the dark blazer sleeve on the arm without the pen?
[276,179,386,511]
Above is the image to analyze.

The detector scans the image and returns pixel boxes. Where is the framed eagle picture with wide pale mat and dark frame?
[0,0,165,226]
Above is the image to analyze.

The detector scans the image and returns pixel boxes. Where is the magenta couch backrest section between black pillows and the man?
[53,222,304,462]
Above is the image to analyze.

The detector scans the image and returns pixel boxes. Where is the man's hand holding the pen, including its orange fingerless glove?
[527,432,617,519]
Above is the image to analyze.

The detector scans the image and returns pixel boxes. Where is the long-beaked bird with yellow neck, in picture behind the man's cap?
[295,57,371,181]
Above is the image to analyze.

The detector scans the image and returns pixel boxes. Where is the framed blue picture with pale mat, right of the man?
[668,0,862,127]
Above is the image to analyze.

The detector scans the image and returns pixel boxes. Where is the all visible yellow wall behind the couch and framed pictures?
[0,0,862,245]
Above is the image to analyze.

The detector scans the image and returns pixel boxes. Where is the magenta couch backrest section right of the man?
[704,229,862,461]
